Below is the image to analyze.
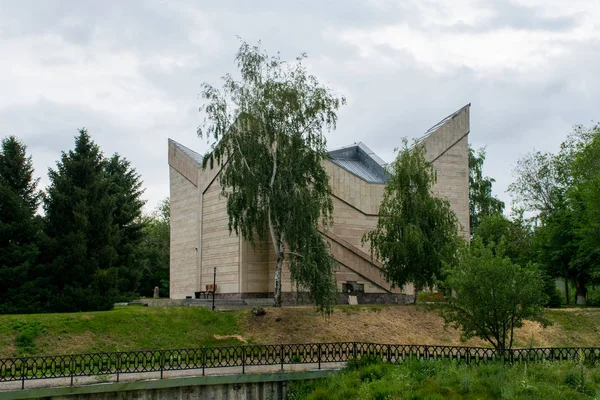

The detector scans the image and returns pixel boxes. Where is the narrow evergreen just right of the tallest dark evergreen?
[105,154,145,295]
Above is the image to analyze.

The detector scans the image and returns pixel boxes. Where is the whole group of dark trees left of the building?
[0,129,169,313]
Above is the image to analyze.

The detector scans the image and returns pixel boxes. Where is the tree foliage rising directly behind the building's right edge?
[469,146,504,235]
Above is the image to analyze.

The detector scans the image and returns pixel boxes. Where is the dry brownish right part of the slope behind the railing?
[241,306,600,347]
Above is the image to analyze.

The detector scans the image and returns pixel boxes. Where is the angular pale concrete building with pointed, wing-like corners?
[169,105,470,303]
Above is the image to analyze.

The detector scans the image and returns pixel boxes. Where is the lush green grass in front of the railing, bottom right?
[288,360,600,400]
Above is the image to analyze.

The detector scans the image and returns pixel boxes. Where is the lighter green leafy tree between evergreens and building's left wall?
[137,198,171,297]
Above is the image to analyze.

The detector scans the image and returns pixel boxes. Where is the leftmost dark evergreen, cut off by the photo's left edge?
[0,136,46,314]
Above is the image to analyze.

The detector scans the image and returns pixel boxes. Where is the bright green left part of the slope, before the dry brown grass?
[0,306,240,357]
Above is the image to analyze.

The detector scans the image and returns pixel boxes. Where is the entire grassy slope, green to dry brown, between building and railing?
[0,306,600,357]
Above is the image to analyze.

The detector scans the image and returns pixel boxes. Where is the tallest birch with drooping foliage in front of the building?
[198,39,345,312]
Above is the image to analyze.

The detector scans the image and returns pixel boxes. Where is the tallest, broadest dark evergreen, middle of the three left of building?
[44,129,119,311]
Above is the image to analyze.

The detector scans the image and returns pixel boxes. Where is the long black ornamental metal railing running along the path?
[0,342,600,388]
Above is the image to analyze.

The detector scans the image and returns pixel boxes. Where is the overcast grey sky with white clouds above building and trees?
[0,0,600,209]
